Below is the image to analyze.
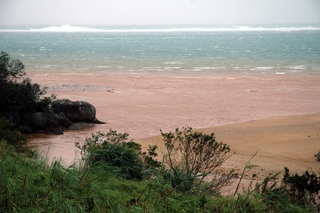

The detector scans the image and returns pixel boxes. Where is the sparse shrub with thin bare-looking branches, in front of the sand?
[161,127,235,192]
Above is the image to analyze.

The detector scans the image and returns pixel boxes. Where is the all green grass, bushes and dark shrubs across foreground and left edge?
[0,52,320,213]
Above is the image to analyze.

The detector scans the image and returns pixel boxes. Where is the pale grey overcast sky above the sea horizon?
[0,0,320,26]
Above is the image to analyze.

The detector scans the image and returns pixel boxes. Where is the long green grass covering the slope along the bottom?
[0,142,316,212]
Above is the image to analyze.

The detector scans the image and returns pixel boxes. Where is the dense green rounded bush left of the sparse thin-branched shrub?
[76,130,160,179]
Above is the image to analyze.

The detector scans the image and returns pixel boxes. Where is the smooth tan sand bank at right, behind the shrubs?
[138,113,320,180]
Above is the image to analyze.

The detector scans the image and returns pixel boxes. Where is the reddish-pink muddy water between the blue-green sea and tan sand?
[28,72,320,174]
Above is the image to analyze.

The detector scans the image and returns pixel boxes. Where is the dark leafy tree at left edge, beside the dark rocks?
[0,52,53,132]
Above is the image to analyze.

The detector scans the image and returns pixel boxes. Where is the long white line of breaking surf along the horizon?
[0,25,320,33]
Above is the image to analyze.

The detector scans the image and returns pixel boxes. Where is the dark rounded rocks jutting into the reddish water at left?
[30,99,104,134]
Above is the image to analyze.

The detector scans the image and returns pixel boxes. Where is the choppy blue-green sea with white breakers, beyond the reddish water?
[0,25,320,74]
